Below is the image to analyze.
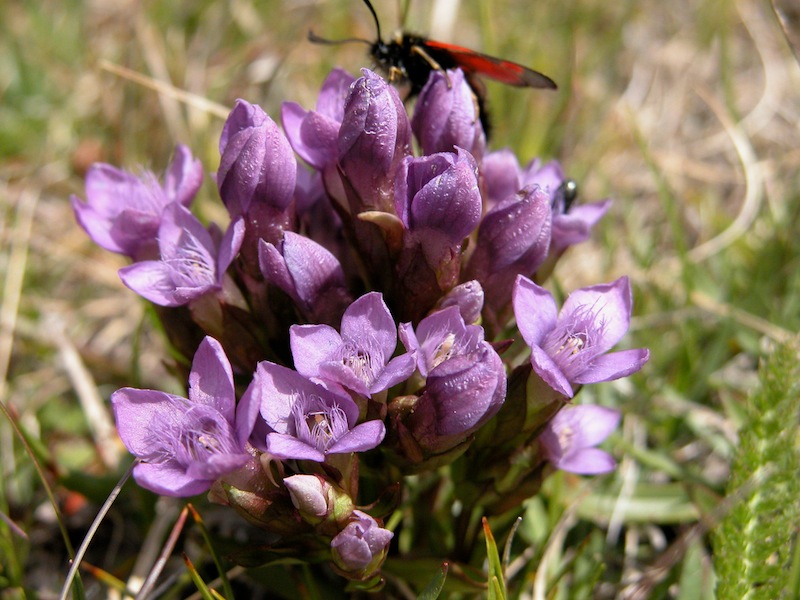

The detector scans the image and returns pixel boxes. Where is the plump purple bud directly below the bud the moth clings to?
[395,148,481,245]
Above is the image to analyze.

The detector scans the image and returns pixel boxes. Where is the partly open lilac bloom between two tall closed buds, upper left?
[281,69,355,171]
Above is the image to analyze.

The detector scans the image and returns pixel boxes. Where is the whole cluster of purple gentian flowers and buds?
[73,69,648,589]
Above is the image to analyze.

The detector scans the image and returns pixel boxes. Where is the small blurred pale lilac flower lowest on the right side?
[539,404,621,475]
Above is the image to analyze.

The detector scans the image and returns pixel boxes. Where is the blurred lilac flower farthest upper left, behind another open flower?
[72,145,203,260]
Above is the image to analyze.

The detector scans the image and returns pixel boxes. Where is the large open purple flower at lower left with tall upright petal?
[111,337,251,496]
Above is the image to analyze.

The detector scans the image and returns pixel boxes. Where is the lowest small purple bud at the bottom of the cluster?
[331,510,394,579]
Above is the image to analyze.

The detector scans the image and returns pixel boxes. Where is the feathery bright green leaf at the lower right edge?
[713,341,800,599]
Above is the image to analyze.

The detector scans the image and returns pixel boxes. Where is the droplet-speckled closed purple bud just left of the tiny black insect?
[466,187,552,312]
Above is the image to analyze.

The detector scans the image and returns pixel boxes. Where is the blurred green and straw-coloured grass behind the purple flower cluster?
[0,0,800,598]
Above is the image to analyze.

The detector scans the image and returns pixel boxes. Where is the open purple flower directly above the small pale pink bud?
[239,362,386,462]
